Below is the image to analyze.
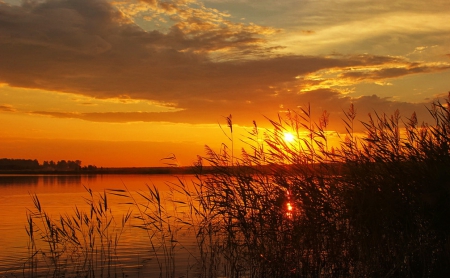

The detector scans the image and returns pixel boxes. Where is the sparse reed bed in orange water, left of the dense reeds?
[24,182,197,277]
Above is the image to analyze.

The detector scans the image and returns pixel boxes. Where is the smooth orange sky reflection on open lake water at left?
[0,175,197,276]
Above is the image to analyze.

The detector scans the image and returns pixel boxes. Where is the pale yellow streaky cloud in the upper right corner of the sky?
[270,0,450,56]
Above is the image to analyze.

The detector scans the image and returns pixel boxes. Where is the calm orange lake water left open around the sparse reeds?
[0,175,200,277]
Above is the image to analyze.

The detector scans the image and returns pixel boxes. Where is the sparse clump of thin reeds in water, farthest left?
[24,188,131,277]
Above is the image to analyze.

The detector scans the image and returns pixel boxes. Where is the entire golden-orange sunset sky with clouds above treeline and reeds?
[0,0,450,167]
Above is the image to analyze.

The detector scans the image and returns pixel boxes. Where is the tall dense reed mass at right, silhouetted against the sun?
[192,94,450,277]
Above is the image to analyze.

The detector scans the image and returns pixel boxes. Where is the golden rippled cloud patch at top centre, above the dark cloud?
[115,0,278,57]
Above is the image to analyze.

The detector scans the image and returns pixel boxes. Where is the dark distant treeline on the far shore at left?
[0,158,97,171]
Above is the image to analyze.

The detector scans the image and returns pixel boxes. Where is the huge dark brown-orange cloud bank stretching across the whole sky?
[0,0,449,128]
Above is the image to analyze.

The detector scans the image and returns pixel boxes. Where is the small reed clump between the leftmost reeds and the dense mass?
[109,182,199,277]
